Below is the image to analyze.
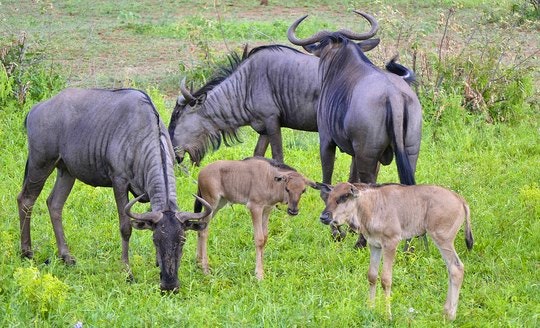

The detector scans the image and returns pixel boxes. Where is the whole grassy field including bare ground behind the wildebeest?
[0,0,540,327]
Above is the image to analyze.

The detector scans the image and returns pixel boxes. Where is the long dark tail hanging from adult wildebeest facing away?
[386,99,416,185]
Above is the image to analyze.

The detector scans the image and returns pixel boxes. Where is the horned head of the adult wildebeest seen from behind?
[287,10,379,57]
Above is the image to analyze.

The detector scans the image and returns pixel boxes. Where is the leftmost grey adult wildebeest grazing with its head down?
[17,89,210,290]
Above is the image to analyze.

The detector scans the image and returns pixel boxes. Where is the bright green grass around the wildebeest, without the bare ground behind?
[0,0,540,327]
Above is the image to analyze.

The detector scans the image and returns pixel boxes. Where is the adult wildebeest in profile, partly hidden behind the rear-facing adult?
[169,39,414,165]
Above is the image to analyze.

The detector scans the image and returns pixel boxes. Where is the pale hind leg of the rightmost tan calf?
[435,241,464,320]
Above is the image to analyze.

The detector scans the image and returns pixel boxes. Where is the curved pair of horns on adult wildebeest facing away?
[287,10,379,46]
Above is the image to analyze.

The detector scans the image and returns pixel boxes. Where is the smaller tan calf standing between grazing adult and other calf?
[195,157,317,279]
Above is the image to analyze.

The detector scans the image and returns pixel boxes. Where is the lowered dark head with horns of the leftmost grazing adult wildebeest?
[125,194,212,292]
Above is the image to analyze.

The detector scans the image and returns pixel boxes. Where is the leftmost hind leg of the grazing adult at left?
[17,159,55,258]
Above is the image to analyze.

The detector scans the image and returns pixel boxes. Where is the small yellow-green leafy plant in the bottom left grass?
[13,266,69,315]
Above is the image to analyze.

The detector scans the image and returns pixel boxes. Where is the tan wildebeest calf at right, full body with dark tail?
[320,182,474,320]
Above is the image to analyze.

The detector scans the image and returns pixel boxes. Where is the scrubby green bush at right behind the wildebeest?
[415,10,538,123]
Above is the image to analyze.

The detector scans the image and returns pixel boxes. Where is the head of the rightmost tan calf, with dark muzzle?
[318,182,362,226]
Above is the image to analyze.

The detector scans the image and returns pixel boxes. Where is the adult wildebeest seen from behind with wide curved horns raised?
[287,11,422,185]
